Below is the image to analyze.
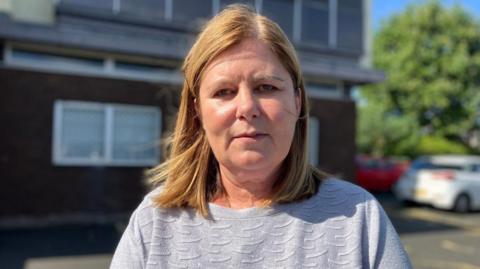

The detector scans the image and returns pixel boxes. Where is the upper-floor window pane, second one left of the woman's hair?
[120,0,165,19]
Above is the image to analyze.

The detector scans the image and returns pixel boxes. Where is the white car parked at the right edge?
[393,155,480,212]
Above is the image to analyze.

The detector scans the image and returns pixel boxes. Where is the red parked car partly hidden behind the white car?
[356,156,409,192]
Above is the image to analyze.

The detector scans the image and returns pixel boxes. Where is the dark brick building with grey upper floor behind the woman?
[0,0,383,220]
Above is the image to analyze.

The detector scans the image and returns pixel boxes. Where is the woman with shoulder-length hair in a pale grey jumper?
[111,5,411,268]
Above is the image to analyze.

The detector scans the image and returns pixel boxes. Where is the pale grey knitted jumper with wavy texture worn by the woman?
[110,179,411,269]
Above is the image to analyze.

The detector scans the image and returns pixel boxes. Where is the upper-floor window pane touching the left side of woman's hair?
[172,0,212,25]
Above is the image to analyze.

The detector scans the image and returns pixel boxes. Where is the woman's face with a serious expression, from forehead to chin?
[196,39,300,176]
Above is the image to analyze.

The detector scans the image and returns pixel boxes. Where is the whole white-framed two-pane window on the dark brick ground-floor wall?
[52,100,161,166]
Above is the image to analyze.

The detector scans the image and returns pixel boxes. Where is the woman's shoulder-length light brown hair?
[148,4,323,217]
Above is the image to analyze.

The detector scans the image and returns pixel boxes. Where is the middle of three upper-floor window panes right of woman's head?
[301,0,329,45]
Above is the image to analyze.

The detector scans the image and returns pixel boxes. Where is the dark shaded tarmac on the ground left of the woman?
[0,224,121,269]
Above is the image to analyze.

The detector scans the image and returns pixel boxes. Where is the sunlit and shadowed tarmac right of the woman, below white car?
[376,193,480,269]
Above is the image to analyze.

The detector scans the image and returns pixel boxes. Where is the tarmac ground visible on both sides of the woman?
[0,193,480,269]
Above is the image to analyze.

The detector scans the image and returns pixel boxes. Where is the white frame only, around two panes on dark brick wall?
[52,100,162,167]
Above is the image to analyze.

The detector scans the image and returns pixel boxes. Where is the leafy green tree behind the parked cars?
[358,1,480,155]
